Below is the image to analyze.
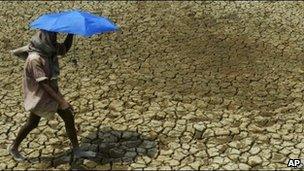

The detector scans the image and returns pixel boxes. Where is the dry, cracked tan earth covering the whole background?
[0,1,304,170]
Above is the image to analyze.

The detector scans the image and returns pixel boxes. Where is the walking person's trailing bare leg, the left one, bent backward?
[9,113,41,161]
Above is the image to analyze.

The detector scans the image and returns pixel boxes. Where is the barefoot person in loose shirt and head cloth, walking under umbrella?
[8,30,94,161]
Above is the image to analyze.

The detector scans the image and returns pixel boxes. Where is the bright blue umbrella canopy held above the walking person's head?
[30,10,118,37]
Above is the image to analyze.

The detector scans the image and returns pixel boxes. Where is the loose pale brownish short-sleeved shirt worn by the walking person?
[23,44,65,119]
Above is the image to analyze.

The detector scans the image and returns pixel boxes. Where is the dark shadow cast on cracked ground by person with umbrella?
[28,128,158,170]
